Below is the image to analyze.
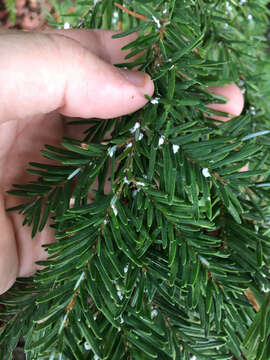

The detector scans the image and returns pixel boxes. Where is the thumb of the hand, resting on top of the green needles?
[0,31,154,122]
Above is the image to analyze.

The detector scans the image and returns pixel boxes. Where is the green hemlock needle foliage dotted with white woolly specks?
[0,0,270,360]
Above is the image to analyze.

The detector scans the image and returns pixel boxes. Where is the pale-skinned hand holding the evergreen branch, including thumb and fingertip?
[0,30,244,294]
